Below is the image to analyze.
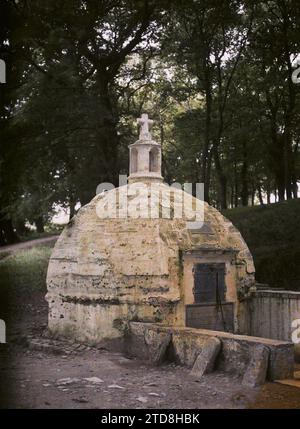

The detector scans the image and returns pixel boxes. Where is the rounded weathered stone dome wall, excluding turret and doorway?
[47,183,254,343]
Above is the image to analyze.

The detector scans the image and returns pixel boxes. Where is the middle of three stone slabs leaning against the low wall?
[191,338,221,378]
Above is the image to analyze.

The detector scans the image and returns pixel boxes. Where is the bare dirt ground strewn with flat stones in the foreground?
[1,340,255,409]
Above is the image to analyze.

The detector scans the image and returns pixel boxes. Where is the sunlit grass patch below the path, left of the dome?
[0,246,52,296]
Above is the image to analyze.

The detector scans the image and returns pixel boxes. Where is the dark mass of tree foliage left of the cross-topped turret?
[0,0,159,244]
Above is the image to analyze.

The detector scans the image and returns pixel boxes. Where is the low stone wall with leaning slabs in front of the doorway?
[125,322,294,380]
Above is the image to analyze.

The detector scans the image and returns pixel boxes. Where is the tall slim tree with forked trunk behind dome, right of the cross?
[162,1,252,208]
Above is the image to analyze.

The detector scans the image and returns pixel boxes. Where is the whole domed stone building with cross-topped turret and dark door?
[46,115,254,343]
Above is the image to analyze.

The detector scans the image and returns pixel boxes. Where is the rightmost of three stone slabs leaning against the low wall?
[242,345,270,387]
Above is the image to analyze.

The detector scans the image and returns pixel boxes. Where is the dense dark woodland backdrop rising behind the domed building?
[0,0,300,244]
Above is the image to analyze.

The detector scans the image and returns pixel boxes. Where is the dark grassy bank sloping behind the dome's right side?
[223,199,300,290]
